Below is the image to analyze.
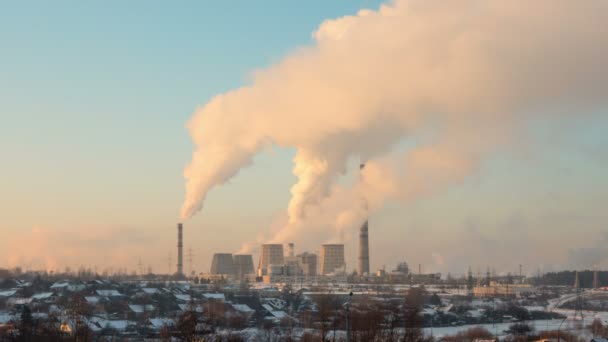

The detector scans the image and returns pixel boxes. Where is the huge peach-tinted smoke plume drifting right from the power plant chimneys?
[181,0,608,246]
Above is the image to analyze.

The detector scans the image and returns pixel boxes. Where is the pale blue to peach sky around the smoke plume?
[0,1,608,274]
